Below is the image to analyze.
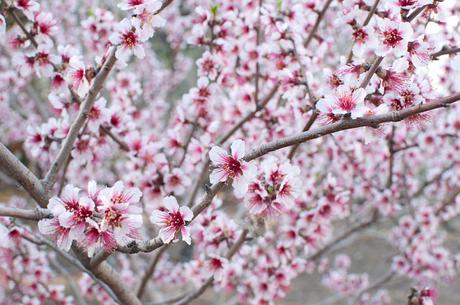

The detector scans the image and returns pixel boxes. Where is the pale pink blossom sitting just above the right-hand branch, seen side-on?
[316,86,366,119]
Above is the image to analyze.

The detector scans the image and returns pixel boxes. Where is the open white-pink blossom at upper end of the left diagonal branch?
[110,19,146,62]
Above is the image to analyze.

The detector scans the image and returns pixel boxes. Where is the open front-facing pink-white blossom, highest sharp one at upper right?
[375,19,413,56]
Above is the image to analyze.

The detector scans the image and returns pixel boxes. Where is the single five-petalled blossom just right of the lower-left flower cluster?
[150,196,193,245]
